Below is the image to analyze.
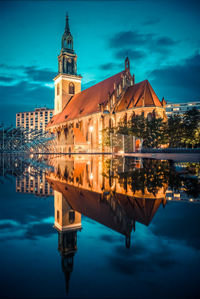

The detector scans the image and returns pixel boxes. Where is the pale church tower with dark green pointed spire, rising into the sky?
[54,15,82,114]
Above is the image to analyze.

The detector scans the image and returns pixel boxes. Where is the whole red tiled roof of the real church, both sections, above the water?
[47,71,163,128]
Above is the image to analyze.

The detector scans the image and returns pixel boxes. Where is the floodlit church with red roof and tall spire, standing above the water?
[47,16,166,153]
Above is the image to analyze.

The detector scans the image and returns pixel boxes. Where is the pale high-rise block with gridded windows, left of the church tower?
[16,107,54,132]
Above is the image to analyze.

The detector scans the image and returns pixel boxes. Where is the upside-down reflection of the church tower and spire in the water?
[54,191,81,293]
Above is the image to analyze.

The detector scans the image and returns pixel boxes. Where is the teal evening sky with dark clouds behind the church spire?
[0,0,200,125]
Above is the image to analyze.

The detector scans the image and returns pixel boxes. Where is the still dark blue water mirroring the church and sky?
[0,155,200,298]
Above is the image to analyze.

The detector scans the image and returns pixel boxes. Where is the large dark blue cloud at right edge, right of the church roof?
[149,53,200,101]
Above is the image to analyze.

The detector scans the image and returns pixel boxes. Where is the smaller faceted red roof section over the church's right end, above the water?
[115,80,162,112]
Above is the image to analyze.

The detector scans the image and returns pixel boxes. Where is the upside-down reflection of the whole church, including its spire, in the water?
[47,156,166,293]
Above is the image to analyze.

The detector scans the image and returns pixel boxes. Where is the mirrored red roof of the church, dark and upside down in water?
[47,177,163,235]
